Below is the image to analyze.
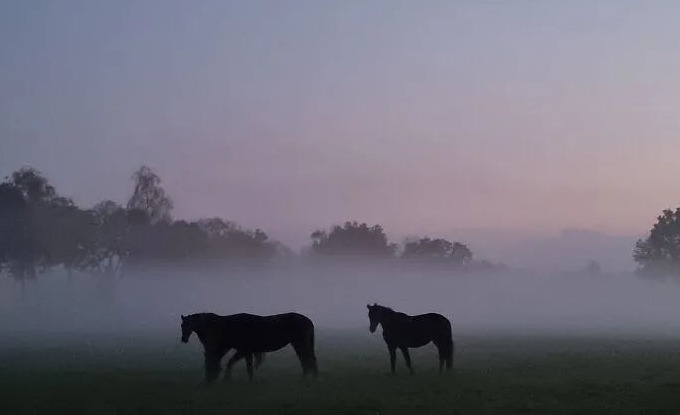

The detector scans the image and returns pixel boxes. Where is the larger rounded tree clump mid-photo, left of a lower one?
[311,221,396,257]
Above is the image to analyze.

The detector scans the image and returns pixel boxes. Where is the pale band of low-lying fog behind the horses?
[0,263,680,339]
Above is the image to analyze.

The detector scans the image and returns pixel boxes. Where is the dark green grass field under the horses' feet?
[0,332,680,415]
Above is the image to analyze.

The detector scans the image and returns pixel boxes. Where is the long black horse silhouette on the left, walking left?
[182,313,317,382]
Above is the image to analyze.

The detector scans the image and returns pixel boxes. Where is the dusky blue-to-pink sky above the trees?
[0,0,680,264]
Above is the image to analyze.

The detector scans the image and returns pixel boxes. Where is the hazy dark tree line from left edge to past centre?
[0,166,478,280]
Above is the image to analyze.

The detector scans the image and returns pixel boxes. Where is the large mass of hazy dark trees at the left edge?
[0,166,287,281]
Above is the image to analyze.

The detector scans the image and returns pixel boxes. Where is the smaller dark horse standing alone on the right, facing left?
[367,304,453,374]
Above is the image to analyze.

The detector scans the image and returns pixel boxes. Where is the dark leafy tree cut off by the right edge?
[633,208,680,277]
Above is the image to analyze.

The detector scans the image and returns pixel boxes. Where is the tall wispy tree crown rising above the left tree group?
[127,166,173,224]
